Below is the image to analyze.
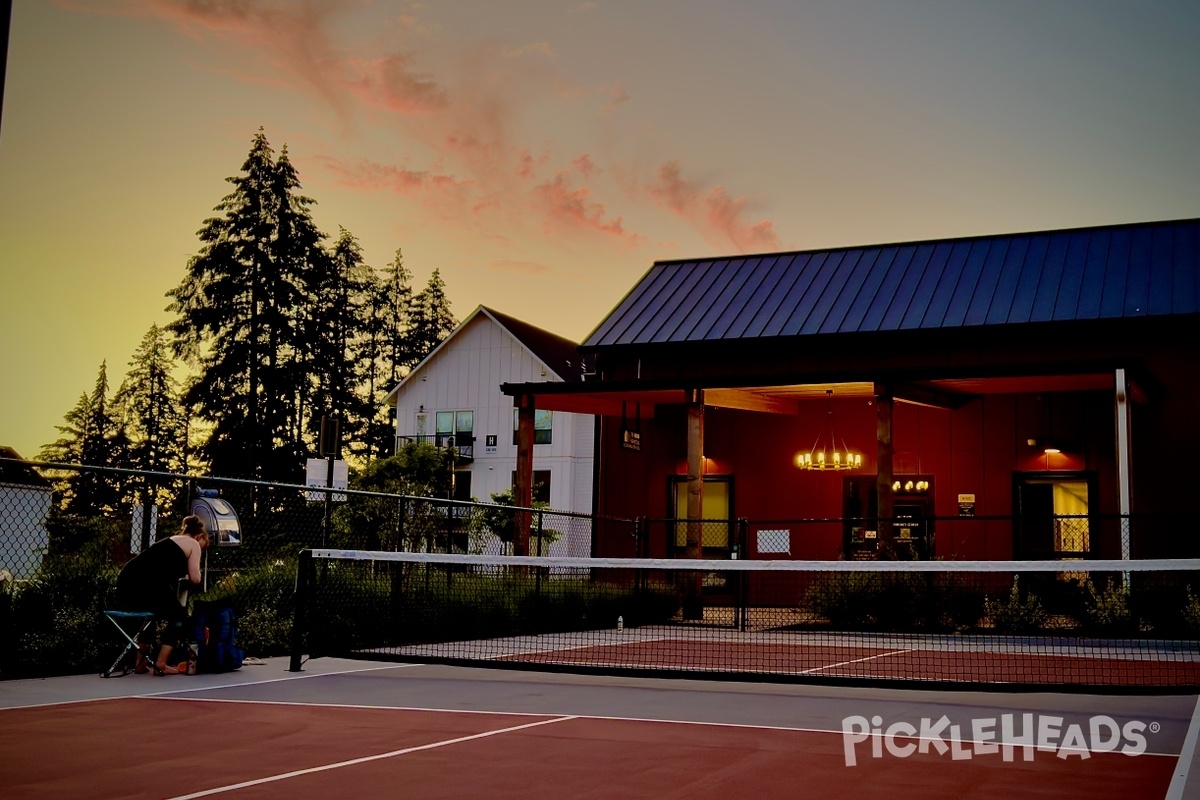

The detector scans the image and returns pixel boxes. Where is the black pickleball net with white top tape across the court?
[292,549,1200,691]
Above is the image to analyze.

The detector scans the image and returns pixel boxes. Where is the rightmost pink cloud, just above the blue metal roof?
[646,161,780,253]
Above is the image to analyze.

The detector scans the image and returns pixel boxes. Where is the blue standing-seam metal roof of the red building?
[582,219,1200,348]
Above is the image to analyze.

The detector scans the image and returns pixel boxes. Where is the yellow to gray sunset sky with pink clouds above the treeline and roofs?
[0,0,1200,457]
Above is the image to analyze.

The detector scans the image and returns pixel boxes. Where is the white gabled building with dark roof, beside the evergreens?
[388,306,595,555]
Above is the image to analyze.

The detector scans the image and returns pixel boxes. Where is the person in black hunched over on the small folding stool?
[116,516,209,675]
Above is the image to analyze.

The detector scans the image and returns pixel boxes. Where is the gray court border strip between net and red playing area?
[7,658,1200,800]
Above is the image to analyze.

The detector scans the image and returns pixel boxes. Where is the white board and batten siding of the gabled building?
[394,309,595,555]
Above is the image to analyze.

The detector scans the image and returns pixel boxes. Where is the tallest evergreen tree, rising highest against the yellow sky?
[168,130,324,481]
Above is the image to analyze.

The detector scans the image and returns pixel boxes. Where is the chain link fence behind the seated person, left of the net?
[0,458,635,679]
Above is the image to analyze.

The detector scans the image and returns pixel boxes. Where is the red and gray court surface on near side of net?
[7,658,1200,800]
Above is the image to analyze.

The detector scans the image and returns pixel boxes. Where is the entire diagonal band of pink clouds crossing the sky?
[63,0,779,258]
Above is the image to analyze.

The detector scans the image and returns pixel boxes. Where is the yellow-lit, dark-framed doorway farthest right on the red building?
[1015,474,1093,559]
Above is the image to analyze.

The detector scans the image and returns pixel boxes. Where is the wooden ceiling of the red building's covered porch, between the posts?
[504,373,1123,419]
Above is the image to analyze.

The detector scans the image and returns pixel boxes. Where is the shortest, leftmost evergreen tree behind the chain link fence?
[38,362,128,515]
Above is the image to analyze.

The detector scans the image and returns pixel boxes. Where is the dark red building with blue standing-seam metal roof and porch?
[504,219,1200,559]
